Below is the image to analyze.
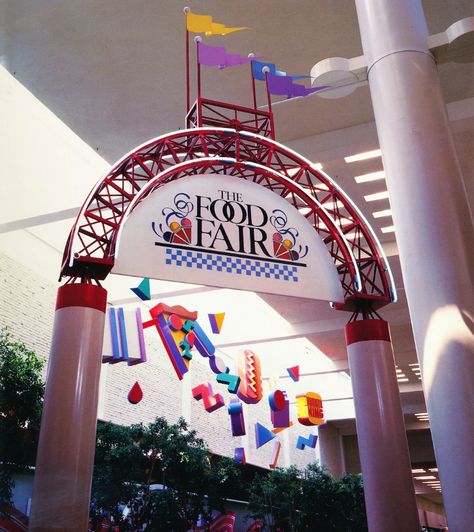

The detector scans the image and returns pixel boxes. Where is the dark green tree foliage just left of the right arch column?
[249,463,367,532]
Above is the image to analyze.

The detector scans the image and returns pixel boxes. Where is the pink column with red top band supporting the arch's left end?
[29,284,107,532]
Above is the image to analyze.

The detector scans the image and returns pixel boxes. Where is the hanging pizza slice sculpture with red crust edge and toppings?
[150,303,197,380]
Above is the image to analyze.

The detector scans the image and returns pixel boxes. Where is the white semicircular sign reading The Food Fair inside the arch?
[112,174,343,302]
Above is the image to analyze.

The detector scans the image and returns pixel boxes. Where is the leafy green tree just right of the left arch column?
[92,418,243,531]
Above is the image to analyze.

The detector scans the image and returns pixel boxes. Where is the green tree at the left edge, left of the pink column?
[0,329,44,509]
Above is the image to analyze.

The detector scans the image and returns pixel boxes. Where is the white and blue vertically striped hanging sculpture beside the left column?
[102,307,146,366]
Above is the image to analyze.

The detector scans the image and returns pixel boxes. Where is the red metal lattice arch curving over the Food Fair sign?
[61,127,395,311]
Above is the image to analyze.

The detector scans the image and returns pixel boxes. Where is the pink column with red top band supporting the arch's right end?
[346,319,420,532]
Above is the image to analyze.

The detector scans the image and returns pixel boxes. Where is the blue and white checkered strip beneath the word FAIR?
[166,248,298,283]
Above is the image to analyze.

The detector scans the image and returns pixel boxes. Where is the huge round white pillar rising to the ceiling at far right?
[356,0,474,532]
